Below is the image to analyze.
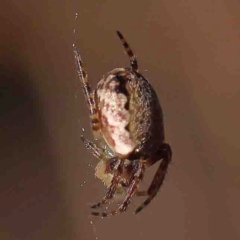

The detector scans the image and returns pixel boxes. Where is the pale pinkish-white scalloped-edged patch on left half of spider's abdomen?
[96,68,137,156]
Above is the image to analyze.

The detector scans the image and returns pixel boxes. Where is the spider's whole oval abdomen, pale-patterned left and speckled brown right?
[96,68,164,158]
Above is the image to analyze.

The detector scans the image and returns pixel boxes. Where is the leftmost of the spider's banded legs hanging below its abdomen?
[91,158,124,210]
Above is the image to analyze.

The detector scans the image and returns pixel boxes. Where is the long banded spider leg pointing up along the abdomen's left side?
[73,44,100,131]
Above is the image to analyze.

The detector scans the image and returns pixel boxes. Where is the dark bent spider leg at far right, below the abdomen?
[135,143,172,214]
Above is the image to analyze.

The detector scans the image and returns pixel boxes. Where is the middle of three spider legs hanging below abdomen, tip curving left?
[92,160,145,217]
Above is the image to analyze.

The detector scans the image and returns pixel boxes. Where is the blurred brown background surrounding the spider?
[0,0,240,240]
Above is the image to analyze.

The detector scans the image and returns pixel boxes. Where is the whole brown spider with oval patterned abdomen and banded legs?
[73,31,172,217]
